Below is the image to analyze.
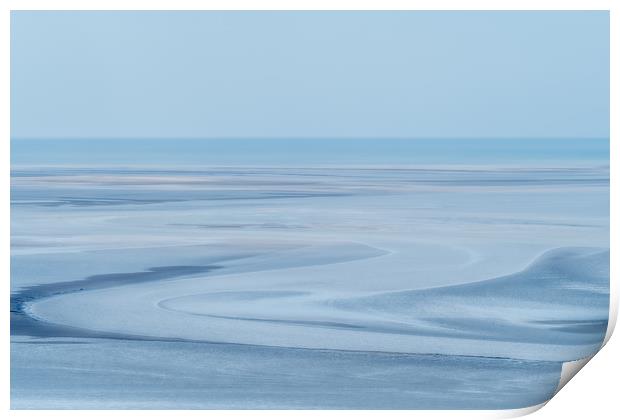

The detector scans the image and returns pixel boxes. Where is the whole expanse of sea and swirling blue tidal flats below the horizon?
[11,140,609,409]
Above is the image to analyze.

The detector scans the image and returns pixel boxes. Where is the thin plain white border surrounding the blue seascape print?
[0,0,620,420]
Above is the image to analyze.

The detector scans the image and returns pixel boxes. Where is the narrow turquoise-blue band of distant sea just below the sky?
[11,138,609,166]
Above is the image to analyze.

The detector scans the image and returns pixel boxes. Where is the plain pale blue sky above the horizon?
[11,11,609,139]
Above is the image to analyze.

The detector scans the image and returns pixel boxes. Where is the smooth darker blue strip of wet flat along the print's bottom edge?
[11,339,561,409]
